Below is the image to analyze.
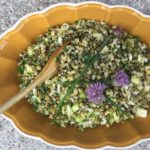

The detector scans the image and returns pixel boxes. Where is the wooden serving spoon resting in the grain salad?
[0,42,69,114]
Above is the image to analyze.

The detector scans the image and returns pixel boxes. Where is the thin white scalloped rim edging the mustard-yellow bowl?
[0,1,150,150]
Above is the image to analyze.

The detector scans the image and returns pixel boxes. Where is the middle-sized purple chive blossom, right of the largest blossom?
[114,70,129,86]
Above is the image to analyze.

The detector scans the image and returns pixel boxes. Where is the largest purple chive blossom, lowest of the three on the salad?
[86,82,106,103]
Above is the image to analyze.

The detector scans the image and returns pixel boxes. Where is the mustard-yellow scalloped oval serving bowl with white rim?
[0,2,150,148]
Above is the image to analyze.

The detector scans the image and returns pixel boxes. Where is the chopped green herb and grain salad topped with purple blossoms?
[18,19,150,130]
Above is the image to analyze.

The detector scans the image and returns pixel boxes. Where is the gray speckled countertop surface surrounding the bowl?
[0,0,150,150]
